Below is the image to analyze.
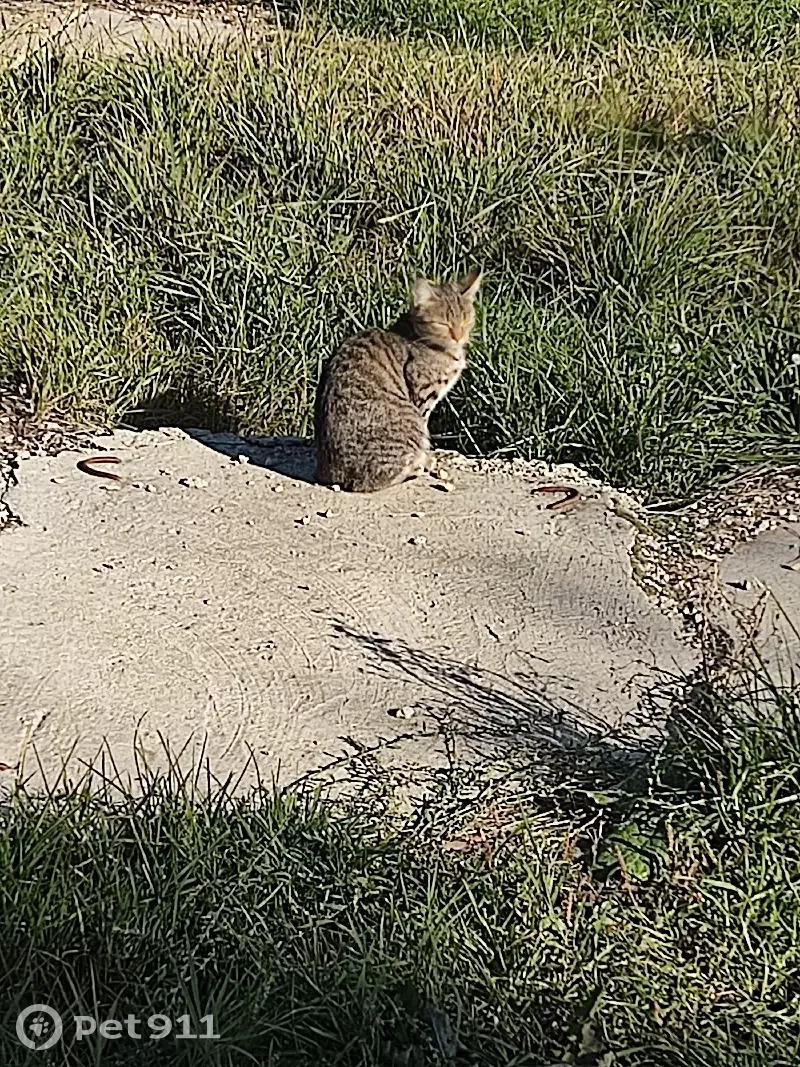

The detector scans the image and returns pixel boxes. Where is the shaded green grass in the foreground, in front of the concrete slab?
[0,661,800,1067]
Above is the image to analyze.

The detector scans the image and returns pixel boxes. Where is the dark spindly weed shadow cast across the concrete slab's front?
[293,622,682,802]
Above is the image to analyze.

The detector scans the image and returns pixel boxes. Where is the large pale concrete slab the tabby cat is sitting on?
[0,430,691,783]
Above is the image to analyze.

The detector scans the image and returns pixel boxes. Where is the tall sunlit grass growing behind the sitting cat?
[0,29,800,495]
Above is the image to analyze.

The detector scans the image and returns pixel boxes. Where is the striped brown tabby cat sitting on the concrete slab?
[315,270,481,493]
